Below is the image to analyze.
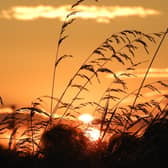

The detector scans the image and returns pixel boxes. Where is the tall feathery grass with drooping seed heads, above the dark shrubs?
[0,0,168,155]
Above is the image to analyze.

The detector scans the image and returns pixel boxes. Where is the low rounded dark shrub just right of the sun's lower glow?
[104,133,141,168]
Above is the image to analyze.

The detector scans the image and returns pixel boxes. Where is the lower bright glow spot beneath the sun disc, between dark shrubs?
[85,127,100,141]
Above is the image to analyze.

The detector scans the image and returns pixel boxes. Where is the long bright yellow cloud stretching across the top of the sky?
[0,5,160,23]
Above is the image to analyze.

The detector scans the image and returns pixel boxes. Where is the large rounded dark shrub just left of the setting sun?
[42,124,94,167]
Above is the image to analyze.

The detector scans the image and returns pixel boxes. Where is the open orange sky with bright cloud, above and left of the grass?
[0,0,168,109]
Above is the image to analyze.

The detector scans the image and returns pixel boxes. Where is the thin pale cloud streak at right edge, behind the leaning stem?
[107,68,168,79]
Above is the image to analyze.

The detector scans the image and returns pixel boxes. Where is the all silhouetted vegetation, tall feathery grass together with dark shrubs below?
[0,0,168,168]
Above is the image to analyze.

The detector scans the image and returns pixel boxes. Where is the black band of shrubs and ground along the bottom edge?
[0,113,168,168]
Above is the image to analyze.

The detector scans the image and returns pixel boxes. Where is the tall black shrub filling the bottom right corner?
[137,113,168,167]
